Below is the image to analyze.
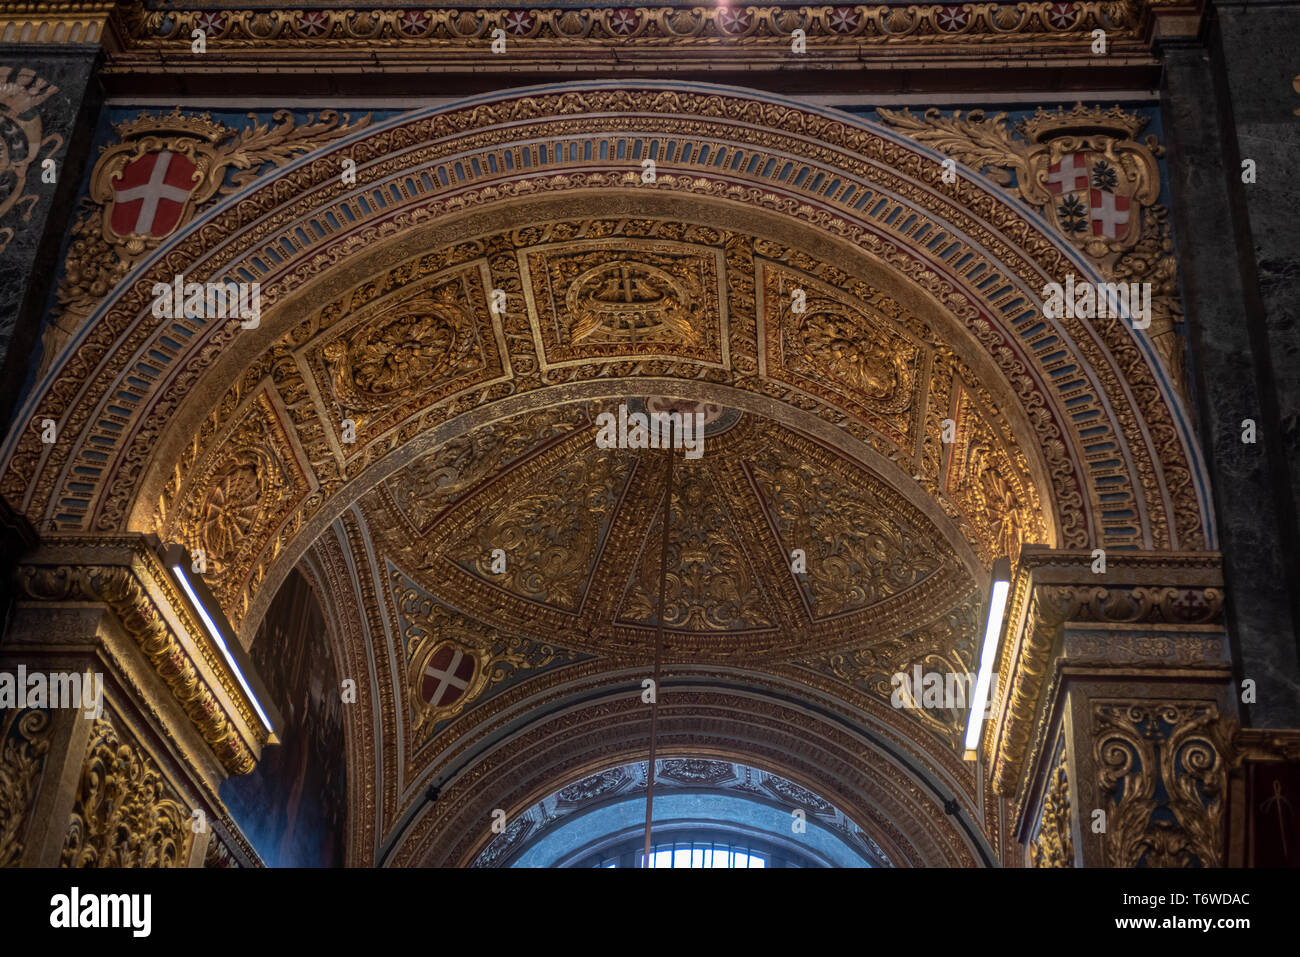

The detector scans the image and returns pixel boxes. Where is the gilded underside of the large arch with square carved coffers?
[152,204,1050,634]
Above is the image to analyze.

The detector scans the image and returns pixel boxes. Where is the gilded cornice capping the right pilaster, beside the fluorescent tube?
[984,547,1223,794]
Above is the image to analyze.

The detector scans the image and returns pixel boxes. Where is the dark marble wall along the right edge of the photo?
[1161,3,1300,728]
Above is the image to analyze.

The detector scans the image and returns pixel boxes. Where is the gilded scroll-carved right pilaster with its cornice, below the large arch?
[984,549,1238,867]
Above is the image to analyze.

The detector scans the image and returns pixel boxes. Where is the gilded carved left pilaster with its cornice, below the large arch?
[0,536,269,867]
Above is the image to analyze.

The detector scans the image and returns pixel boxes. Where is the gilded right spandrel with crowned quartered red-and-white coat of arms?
[879,104,1184,400]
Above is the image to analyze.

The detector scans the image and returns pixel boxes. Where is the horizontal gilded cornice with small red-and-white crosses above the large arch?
[94,0,1180,73]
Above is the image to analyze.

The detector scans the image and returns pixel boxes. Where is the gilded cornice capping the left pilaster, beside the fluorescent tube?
[16,536,268,774]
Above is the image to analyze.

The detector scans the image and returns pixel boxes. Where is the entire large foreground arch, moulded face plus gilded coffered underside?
[0,82,1213,861]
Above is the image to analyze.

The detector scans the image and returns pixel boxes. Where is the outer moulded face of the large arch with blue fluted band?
[4,87,1204,629]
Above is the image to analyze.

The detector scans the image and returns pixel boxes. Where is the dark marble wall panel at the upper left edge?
[0,44,101,442]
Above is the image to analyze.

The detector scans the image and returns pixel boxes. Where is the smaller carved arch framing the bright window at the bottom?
[381,676,996,867]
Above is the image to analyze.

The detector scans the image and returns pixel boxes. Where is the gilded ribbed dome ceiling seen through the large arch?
[317,399,979,750]
